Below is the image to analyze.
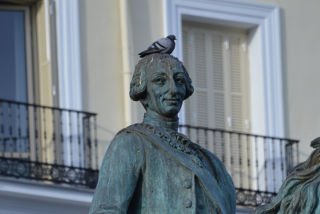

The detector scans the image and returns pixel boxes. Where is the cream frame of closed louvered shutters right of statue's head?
[183,22,251,132]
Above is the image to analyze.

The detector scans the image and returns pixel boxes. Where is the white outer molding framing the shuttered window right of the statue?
[165,0,285,137]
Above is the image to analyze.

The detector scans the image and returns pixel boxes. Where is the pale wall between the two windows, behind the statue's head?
[79,0,164,162]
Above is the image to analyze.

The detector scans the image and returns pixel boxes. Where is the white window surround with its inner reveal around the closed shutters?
[164,0,285,137]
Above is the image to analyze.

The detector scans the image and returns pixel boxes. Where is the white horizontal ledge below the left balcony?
[0,177,93,214]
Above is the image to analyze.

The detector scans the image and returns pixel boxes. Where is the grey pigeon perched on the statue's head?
[139,35,176,58]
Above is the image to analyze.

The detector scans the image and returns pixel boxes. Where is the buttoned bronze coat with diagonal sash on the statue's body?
[90,124,236,214]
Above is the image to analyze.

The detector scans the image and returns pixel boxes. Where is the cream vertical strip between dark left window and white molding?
[33,0,54,161]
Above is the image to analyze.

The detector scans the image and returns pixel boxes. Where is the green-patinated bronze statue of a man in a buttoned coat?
[90,53,236,214]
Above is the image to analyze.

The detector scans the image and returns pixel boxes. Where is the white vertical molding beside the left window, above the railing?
[56,0,82,110]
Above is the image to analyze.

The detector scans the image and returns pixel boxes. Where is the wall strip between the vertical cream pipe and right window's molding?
[123,0,166,123]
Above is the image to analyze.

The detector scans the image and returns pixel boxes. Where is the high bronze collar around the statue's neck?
[143,111,179,132]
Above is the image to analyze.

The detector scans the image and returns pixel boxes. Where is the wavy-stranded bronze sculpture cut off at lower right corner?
[256,137,320,214]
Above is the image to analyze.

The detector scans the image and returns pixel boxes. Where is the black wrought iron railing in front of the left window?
[0,99,98,188]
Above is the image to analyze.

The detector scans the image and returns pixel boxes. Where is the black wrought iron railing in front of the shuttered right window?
[180,125,299,207]
